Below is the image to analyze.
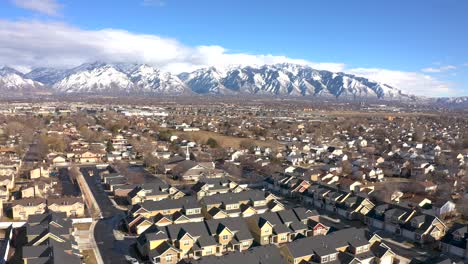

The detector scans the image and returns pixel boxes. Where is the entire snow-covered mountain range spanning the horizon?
[0,62,466,103]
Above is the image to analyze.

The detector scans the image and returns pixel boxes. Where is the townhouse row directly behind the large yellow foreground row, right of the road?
[125,190,284,234]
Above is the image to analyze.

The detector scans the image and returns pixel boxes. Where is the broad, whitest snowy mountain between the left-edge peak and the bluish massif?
[53,62,187,95]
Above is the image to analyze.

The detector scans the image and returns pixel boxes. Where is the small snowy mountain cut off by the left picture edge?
[0,67,44,94]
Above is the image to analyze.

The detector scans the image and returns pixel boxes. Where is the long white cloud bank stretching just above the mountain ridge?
[0,20,451,96]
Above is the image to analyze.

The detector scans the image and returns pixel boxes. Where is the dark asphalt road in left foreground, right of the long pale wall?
[80,166,135,264]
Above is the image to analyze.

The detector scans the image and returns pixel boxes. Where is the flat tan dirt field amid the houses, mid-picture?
[171,130,279,149]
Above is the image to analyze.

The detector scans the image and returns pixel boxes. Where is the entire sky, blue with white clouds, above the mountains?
[0,0,468,96]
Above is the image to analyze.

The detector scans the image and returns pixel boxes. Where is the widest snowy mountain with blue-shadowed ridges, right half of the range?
[179,63,408,99]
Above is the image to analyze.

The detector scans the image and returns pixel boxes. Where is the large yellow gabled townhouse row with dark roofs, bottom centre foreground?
[137,208,329,263]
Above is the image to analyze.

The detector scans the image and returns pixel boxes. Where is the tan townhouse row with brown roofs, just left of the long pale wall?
[11,197,85,220]
